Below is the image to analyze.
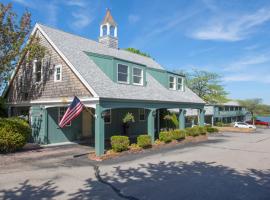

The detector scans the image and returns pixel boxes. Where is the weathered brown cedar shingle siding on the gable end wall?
[7,31,93,103]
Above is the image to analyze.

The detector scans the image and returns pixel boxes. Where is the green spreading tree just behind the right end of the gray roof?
[186,70,228,104]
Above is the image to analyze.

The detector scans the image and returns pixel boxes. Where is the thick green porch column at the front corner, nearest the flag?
[95,104,105,156]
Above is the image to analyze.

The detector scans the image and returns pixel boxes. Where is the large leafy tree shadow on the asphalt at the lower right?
[69,162,270,200]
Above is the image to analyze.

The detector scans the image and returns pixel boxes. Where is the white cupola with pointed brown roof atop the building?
[99,9,118,49]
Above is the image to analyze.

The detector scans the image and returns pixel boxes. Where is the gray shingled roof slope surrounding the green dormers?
[39,24,204,103]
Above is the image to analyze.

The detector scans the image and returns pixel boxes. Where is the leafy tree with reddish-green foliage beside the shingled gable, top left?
[0,3,45,90]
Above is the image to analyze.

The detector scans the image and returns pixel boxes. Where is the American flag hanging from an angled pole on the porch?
[59,96,84,128]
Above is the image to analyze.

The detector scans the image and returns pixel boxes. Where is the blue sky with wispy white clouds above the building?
[3,0,270,104]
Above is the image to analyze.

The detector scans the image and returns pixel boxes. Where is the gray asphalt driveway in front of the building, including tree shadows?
[0,129,270,200]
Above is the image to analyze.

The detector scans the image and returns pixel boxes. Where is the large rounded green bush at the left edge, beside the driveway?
[0,118,31,153]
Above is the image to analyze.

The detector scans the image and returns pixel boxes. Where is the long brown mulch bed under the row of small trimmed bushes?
[88,135,208,161]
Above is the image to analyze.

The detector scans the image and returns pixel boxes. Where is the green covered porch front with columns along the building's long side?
[94,99,205,156]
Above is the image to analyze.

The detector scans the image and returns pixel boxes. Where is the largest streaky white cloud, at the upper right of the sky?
[191,8,270,41]
